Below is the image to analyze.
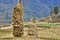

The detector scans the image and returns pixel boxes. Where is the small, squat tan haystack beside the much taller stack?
[28,24,38,37]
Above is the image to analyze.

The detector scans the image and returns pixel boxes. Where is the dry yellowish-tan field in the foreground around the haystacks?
[0,27,60,40]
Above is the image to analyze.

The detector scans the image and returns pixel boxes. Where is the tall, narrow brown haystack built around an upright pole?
[12,0,24,37]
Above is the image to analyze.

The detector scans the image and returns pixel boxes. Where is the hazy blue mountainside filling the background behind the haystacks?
[0,0,60,21]
